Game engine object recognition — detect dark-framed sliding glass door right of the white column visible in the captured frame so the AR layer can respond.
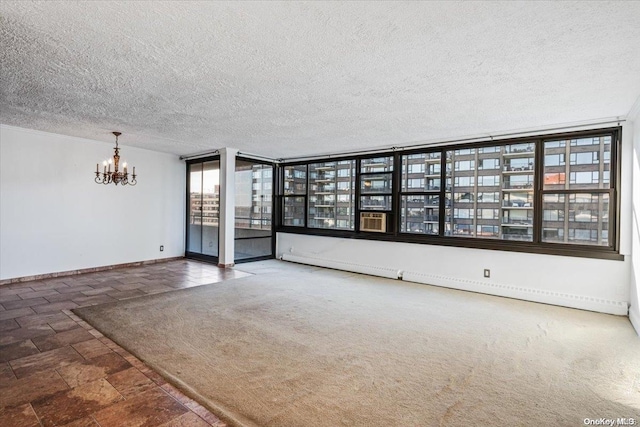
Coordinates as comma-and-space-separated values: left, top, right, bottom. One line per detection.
234, 159, 273, 262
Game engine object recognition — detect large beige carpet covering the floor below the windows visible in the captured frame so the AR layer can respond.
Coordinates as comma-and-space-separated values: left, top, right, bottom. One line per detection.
75, 261, 640, 426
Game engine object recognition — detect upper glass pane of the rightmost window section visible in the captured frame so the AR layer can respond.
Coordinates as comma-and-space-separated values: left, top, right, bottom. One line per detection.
544, 135, 611, 190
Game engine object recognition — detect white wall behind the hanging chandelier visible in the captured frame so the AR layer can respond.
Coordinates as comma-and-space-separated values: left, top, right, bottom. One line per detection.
0, 125, 185, 279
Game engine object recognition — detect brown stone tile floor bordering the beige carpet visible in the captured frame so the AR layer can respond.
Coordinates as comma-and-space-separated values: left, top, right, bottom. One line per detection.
0, 260, 249, 427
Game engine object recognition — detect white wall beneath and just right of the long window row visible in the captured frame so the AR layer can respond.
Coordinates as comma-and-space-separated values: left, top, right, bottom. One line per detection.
277, 124, 640, 318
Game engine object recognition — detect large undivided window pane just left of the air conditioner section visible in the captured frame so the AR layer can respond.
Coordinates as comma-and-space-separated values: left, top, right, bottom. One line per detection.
308, 160, 356, 230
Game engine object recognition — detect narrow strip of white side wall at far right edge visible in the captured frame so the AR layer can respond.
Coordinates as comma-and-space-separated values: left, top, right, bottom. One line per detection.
629, 103, 640, 335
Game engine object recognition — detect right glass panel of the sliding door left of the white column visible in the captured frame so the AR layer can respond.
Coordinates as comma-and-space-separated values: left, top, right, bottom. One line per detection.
201, 160, 220, 256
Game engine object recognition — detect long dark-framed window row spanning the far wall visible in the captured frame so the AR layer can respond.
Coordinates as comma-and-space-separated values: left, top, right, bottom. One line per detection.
281, 129, 620, 259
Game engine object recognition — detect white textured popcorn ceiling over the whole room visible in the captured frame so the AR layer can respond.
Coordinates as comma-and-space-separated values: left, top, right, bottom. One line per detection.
0, 1, 640, 157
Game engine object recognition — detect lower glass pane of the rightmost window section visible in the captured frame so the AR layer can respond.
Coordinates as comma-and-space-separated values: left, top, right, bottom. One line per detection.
542, 193, 610, 246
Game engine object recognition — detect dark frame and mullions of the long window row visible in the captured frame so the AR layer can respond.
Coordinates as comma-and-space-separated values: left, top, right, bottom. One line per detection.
276, 127, 624, 260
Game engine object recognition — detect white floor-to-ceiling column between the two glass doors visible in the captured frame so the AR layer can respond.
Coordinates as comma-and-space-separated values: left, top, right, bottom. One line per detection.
218, 148, 238, 268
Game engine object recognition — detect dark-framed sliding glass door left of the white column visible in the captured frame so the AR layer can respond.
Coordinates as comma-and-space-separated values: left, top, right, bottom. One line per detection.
186, 159, 220, 262
